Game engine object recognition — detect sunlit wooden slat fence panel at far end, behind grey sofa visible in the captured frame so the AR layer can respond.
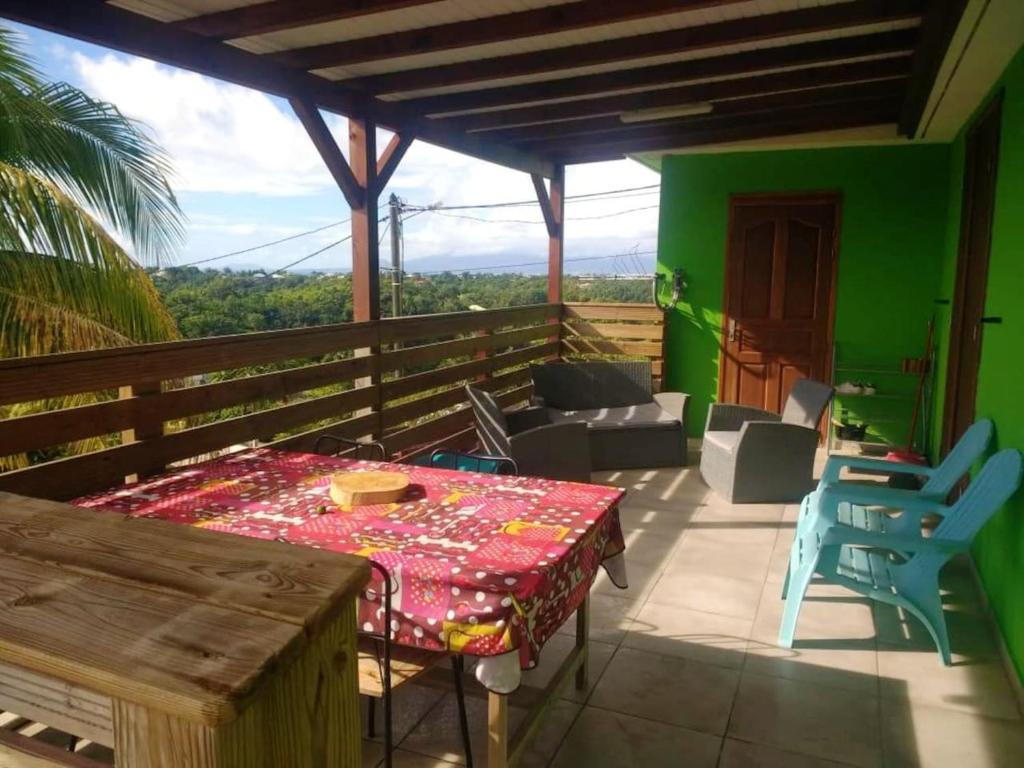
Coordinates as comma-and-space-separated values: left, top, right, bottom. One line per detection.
560, 303, 665, 390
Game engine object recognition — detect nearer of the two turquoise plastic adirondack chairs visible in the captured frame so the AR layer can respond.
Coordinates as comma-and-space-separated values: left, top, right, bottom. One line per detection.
778, 449, 1021, 666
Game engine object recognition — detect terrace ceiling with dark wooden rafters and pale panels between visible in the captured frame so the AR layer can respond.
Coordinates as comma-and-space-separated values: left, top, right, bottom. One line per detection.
0, 0, 966, 176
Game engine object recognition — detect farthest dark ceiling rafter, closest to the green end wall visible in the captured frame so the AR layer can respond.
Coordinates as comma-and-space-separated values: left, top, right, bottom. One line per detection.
556, 98, 900, 163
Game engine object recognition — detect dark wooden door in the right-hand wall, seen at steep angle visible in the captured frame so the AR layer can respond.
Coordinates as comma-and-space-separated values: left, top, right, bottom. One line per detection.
942, 98, 1001, 453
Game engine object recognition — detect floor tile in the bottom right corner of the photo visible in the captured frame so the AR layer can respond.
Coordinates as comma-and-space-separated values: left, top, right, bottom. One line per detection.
882, 699, 1024, 768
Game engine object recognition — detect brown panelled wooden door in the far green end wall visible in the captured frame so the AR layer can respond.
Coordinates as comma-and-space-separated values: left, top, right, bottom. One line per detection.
719, 196, 839, 412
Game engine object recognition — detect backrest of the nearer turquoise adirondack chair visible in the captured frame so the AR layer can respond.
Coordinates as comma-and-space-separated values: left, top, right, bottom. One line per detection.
905, 449, 1022, 570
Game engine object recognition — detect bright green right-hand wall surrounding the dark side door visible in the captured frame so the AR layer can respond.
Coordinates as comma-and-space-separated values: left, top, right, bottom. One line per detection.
937, 48, 1024, 679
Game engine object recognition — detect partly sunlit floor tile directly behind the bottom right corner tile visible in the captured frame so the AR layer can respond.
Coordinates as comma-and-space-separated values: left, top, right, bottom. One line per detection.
879, 643, 1021, 720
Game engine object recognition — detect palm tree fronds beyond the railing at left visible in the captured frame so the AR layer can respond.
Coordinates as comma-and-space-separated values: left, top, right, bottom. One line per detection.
0, 28, 183, 357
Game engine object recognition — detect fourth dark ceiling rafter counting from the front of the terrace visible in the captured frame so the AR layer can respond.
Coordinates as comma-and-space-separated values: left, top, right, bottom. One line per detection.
402, 29, 918, 114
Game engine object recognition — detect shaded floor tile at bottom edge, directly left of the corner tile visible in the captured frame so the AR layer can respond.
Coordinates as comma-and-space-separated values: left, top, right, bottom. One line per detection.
728, 673, 882, 768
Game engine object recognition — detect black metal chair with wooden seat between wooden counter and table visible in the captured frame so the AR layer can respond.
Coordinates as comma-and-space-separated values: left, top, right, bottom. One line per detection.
358, 560, 473, 768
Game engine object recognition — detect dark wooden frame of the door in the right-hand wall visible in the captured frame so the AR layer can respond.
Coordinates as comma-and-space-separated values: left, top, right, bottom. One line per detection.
939, 96, 1004, 456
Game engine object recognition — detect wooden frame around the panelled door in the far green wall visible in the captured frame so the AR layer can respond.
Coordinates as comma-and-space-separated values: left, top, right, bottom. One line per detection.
717, 189, 843, 403
